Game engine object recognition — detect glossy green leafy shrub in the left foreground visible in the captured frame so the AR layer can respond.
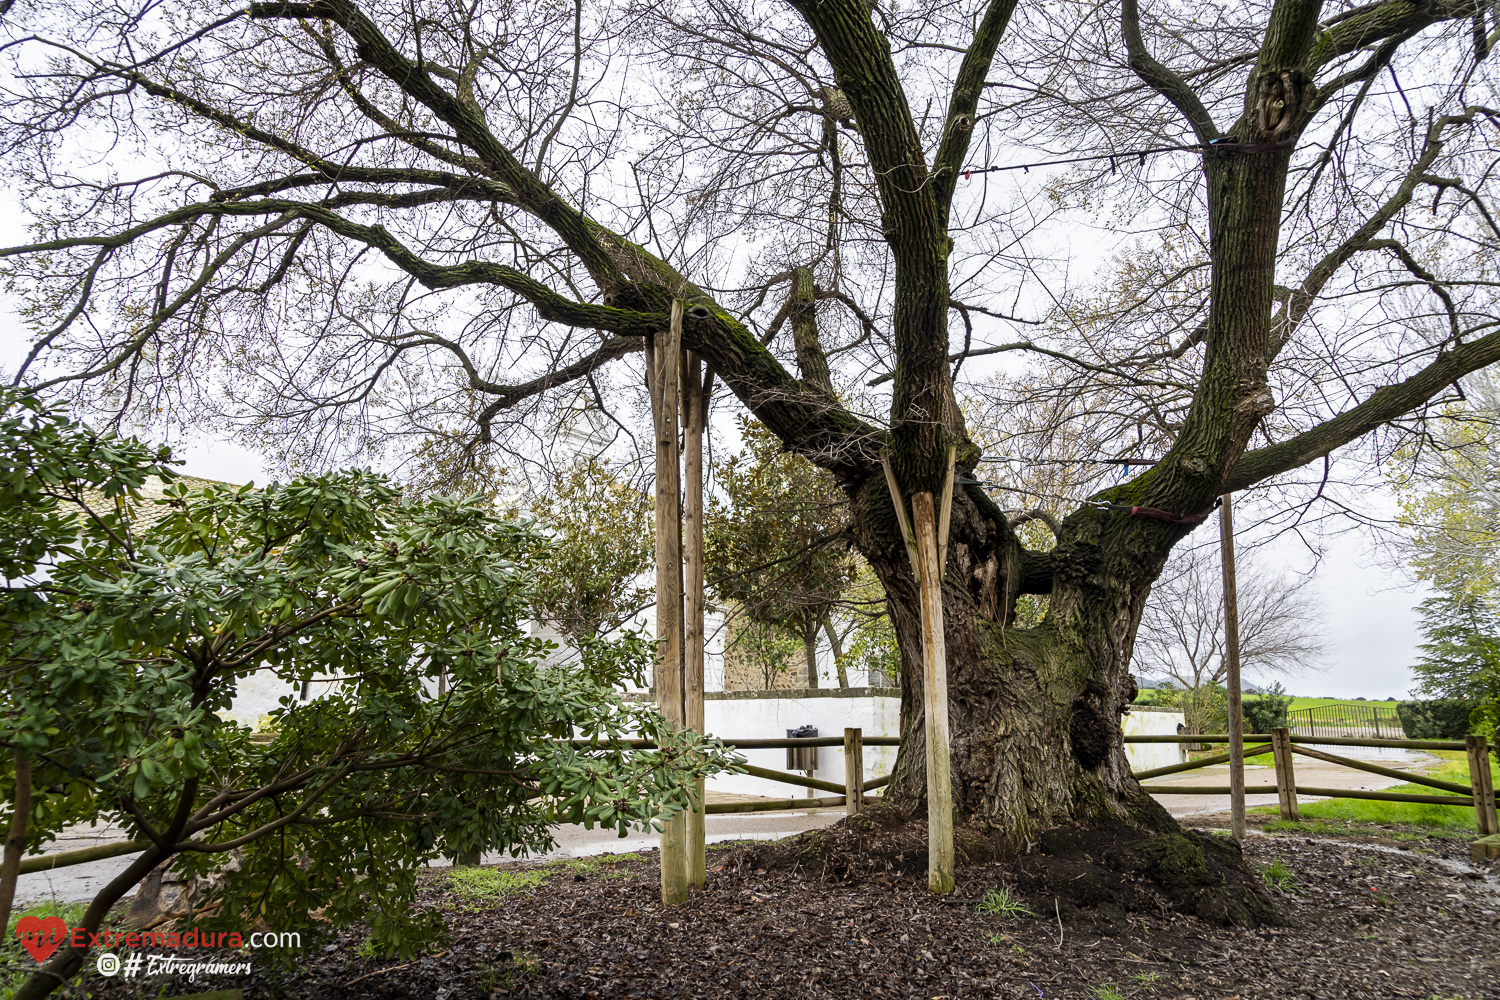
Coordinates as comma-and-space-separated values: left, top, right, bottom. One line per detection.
0, 393, 732, 996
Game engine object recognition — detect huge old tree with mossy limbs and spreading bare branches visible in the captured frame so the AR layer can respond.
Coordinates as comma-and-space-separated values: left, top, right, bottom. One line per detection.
3, 0, 1500, 893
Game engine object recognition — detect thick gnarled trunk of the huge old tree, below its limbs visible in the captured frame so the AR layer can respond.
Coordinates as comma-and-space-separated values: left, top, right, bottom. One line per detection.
855, 470, 1184, 849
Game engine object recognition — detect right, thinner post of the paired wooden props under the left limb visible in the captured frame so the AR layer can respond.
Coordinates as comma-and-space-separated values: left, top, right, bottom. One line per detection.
683, 351, 708, 889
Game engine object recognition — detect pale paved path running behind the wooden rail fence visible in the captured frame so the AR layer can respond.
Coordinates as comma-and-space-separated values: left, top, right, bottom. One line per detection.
8, 753, 1442, 903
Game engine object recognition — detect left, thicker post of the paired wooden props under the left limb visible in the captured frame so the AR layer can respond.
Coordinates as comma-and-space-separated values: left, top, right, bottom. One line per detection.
648, 300, 689, 906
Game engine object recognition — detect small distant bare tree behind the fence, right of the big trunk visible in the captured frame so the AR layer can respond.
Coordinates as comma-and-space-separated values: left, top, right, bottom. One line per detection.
1134, 546, 1329, 688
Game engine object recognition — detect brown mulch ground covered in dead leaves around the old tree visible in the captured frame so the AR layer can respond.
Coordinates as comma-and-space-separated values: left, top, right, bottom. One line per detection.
86, 835, 1500, 1000
